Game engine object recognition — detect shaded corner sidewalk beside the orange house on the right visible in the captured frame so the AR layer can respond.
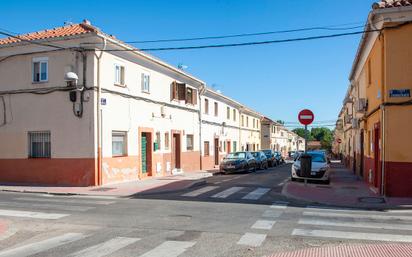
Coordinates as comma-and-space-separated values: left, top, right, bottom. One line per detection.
282, 163, 412, 209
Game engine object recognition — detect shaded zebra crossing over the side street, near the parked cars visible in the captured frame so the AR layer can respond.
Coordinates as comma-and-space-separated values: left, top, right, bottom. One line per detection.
181, 186, 271, 201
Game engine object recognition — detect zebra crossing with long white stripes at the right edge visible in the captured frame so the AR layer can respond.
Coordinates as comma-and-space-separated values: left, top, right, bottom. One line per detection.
291, 206, 412, 243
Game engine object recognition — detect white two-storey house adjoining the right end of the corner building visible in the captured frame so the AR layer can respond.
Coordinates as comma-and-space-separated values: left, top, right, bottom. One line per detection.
201, 88, 243, 170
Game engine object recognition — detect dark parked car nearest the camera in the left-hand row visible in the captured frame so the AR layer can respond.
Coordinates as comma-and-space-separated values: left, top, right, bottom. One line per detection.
219, 152, 257, 174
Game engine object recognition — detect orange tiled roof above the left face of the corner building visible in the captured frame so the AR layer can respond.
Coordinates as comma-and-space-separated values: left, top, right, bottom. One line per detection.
0, 20, 99, 45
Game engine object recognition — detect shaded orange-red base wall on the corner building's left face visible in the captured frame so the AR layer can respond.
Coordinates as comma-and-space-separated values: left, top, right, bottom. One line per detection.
0, 158, 96, 186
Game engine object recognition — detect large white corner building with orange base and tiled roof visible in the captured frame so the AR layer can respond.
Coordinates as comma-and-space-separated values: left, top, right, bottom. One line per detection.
0, 21, 204, 186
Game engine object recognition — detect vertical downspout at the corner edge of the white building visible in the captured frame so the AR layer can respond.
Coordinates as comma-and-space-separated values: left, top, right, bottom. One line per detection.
94, 37, 106, 185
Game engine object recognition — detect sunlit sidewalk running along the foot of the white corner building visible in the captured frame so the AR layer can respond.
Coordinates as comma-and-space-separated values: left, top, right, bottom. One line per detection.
0, 171, 213, 197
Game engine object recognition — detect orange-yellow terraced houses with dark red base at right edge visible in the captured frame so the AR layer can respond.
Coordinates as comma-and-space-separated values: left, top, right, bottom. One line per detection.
340, 0, 412, 197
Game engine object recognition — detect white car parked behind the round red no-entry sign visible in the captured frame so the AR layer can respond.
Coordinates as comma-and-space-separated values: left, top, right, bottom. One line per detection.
291, 151, 330, 184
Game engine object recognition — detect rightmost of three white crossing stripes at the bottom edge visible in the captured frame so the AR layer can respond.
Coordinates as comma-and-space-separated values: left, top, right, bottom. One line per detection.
140, 241, 196, 257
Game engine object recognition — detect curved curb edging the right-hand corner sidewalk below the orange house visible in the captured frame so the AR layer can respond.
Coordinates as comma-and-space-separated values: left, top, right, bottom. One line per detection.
281, 183, 412, 211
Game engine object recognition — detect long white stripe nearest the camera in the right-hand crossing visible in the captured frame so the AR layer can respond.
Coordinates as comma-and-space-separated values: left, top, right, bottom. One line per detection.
292, 229, 412, 243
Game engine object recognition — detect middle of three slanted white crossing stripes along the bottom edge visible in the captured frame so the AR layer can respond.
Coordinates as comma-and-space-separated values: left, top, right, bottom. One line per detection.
69, 237, 140, 257
